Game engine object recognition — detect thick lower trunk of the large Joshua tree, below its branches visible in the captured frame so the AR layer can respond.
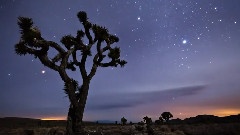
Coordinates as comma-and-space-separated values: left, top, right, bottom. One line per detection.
66, 81, 89, 135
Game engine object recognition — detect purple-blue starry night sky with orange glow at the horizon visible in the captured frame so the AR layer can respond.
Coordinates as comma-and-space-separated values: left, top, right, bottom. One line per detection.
0, 0, 240, 121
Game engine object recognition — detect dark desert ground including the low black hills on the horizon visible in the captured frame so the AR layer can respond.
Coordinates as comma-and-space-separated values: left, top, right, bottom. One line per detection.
0, 115, 240, 135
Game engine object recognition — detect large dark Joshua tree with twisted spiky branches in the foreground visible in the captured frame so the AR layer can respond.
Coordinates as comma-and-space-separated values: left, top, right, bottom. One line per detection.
15, 11, 127, 135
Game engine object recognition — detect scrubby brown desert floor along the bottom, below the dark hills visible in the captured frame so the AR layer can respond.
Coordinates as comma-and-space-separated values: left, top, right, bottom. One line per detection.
0, 123, 240, 135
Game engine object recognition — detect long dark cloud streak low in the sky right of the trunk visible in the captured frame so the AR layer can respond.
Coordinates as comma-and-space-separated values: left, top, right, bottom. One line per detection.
88, 85, 207, 110
